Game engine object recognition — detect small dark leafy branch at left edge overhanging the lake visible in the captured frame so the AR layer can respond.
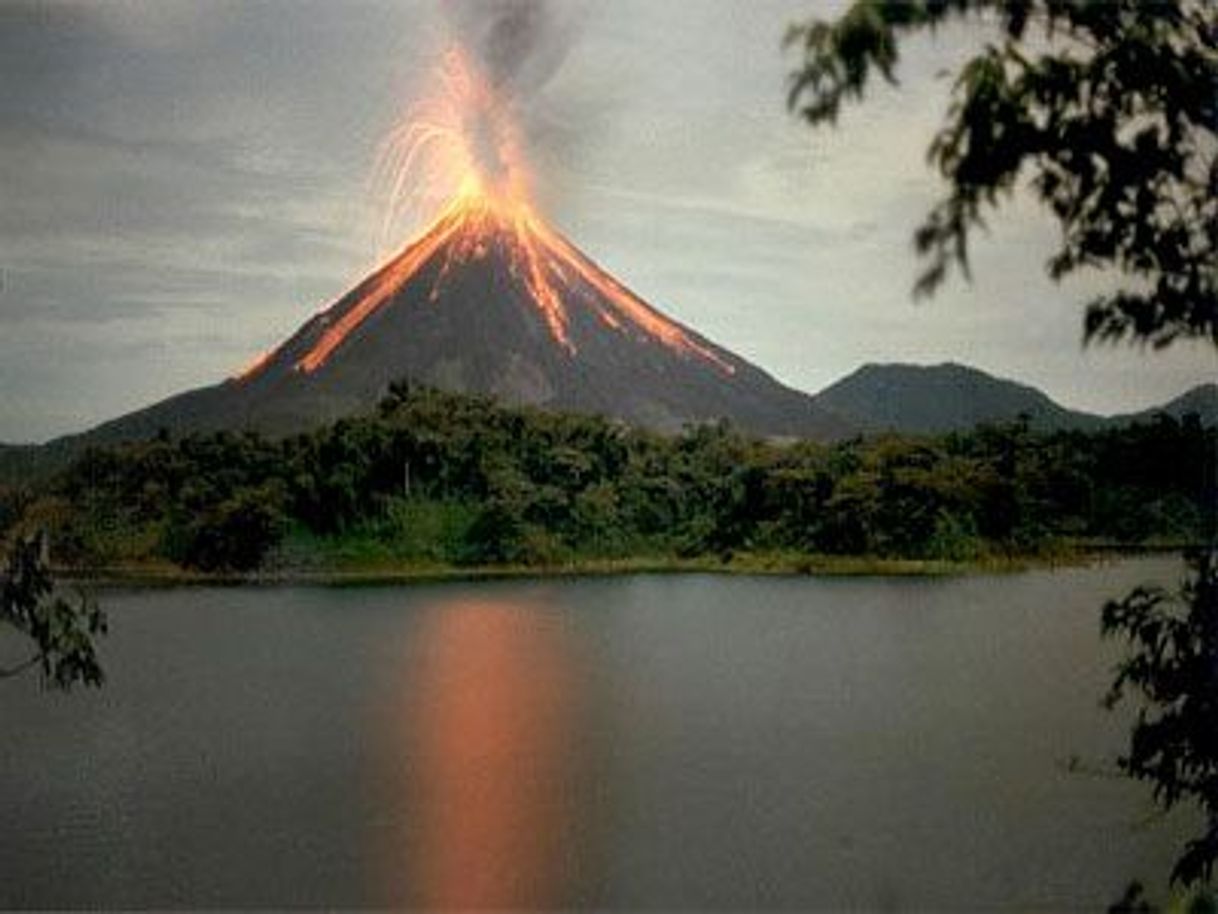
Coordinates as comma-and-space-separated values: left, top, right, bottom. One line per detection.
0, 535, 106, 689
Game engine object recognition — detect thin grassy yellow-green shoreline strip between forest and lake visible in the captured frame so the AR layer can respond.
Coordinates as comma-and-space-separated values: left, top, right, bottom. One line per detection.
47, 547, 1179, 587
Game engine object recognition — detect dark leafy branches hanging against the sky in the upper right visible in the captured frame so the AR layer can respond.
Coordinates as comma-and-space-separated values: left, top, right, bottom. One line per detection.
788, 0, 1218, 346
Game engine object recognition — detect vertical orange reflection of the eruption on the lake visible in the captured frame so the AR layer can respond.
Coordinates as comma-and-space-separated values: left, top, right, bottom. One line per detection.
413, 603, 577, 909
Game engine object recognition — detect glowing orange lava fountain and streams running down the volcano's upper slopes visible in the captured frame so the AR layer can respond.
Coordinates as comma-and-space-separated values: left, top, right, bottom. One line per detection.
245, 51, 734, 378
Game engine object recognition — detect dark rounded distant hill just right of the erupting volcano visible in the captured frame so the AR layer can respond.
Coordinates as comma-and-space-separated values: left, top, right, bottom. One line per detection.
814, 362, 1106, 434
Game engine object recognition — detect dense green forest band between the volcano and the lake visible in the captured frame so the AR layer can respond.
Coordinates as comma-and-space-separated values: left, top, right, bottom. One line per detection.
0, 385, 1218, 572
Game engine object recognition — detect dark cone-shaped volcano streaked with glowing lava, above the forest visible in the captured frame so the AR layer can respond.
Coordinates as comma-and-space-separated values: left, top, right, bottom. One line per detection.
78, 194, 848, 440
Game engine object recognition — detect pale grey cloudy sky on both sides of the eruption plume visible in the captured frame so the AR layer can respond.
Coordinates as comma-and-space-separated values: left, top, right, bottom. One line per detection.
0, 0, 1218, 441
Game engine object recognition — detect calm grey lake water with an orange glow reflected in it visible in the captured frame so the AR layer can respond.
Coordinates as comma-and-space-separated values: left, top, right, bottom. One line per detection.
0, 561, 1188, 910
